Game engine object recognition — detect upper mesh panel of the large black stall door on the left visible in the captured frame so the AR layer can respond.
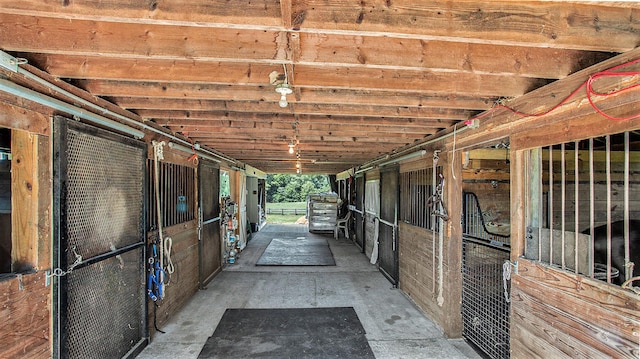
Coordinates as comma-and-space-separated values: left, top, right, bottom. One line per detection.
66, 131, 144, 263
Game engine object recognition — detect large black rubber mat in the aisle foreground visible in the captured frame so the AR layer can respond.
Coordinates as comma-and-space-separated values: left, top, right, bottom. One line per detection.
198, 307, 375, 359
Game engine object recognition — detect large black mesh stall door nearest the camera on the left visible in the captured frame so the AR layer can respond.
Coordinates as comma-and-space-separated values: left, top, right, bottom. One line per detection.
54, 118, 147, 358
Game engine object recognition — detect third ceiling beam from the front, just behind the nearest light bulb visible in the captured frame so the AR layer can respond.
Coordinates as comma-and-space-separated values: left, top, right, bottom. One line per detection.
23, 54, 548, 97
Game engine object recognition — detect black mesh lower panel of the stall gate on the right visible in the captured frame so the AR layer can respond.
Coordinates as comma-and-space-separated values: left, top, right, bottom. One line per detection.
462, 240, 510, 358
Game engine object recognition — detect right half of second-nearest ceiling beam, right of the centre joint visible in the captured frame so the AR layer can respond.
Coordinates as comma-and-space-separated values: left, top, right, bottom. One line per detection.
300, 33, 612, 79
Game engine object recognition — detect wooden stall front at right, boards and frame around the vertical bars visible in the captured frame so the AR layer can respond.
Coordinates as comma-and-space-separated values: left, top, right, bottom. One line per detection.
511, 89, 640, 358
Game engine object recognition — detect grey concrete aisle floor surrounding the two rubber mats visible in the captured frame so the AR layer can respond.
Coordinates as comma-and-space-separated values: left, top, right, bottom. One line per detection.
138, 224, 480, 359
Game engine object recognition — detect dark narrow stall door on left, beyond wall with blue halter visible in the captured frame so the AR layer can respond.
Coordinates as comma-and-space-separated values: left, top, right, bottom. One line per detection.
198, 159, 222, 288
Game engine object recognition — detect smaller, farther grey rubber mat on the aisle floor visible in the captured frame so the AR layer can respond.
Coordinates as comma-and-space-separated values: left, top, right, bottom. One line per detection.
256, 237, 336, 266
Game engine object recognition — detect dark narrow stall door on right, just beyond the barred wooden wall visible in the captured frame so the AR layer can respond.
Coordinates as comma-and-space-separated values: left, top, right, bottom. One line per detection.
378, 167, 399, 285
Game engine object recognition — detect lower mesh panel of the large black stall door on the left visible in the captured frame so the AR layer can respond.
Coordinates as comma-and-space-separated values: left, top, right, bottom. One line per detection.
66, 247, 145, 358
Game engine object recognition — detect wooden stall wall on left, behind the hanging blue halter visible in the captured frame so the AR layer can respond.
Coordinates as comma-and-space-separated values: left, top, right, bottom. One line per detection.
147, 147, 199, 334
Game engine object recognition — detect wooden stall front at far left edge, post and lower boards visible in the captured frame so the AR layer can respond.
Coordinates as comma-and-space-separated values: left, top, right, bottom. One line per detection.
0, 119, 52, 358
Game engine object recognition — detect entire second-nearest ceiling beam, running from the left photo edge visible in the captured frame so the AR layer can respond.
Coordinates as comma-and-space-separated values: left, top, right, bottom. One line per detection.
0, 13, 612, 79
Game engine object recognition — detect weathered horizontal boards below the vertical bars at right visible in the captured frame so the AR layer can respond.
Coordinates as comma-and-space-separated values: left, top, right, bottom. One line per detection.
511, 259, 640, 358
